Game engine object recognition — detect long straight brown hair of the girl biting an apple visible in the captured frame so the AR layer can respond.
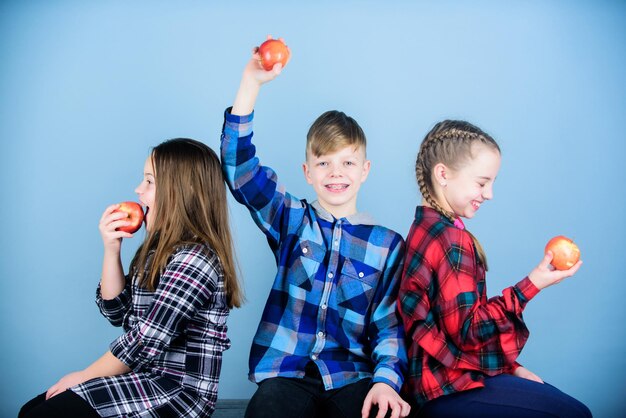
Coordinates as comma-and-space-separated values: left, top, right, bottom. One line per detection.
131, 138, 243, 308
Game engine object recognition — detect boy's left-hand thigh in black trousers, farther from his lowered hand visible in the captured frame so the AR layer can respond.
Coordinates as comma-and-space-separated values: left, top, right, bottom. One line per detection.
245, 377, 323, 418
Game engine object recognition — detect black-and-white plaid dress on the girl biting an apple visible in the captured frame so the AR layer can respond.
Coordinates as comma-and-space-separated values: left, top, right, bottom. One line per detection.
71, 244, 230, 417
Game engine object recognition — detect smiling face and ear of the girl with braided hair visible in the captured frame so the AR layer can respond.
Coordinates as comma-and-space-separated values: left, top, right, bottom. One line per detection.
433, 144, 501, 218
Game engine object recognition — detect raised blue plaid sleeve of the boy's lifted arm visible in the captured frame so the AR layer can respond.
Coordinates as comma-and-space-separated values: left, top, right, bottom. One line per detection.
220, 108, 304, 250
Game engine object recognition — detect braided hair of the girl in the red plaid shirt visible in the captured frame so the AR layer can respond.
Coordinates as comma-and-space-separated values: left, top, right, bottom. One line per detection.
415, 120, 500, 269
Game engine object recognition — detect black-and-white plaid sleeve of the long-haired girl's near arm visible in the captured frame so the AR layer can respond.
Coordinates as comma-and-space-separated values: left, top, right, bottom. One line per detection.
110, 245, 218, 370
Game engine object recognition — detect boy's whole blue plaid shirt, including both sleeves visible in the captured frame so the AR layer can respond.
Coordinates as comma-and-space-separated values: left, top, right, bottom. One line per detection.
221, 109, 407, 391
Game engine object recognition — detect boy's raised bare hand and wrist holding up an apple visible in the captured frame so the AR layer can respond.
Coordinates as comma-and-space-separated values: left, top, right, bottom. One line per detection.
231, 36, 283, 116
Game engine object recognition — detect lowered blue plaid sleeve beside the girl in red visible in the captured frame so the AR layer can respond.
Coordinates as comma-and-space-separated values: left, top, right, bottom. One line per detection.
369, 235, 407, 392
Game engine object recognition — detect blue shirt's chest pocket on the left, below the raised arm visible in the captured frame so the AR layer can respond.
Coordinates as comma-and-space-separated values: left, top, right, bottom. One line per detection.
287, 241, 326, 291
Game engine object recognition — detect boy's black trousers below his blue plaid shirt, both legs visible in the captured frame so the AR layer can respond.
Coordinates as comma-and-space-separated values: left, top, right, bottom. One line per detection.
245, 363, 389, 418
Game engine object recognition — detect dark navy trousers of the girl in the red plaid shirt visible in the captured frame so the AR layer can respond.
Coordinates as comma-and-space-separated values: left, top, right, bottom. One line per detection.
411, 374, 591, 418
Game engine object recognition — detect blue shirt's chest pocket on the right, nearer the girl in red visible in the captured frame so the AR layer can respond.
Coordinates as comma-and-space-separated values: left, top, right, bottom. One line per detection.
337, 258, 380, 315
